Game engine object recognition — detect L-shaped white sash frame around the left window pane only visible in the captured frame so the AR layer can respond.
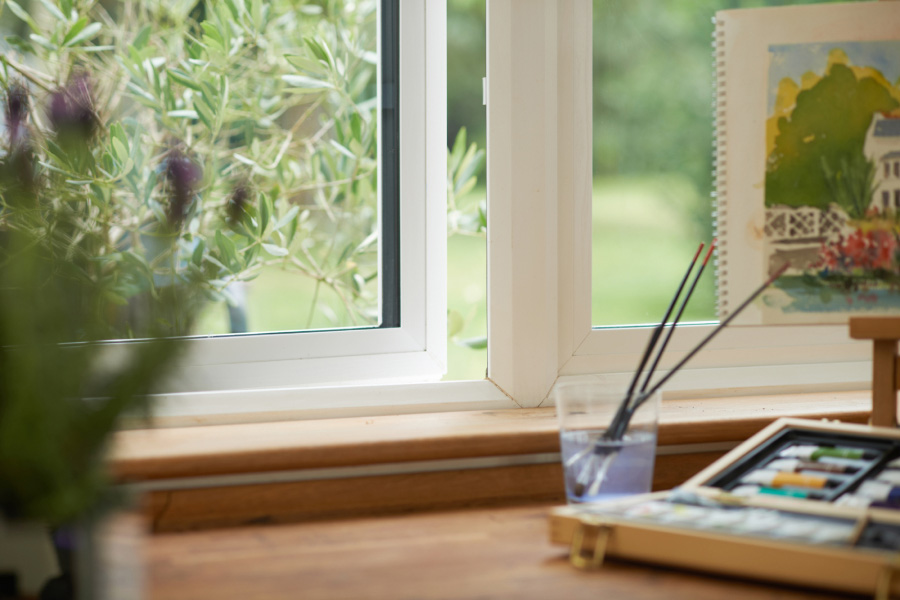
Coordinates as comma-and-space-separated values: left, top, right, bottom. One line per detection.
153, 2, 447, 392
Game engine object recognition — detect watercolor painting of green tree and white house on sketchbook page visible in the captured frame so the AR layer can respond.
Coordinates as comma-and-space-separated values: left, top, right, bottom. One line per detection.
763, 41, 900, 322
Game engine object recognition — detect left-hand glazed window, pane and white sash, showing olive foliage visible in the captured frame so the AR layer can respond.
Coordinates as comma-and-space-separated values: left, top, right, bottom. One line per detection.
0, 0, 444, 398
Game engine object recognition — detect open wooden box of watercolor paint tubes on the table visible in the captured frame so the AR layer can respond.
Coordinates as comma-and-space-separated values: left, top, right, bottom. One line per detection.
550, 419, 900, 597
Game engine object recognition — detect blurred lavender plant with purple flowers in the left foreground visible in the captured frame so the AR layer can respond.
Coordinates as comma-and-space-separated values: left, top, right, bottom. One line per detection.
0, 79, 203, 524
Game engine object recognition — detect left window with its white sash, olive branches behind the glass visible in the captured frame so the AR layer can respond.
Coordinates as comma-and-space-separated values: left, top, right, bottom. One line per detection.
2, 0, 446, 400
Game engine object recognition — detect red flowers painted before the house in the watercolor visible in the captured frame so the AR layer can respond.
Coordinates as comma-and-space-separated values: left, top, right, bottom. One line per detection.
818, 229, 900, 274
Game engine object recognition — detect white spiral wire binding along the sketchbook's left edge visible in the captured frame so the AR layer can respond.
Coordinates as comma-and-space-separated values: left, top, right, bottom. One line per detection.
712, 17, 728, 321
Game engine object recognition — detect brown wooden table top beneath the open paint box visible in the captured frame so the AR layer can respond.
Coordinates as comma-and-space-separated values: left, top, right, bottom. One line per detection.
145, 506, 864, 600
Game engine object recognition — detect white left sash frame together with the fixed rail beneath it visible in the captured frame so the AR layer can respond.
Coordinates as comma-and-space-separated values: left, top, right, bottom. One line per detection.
154, 0, 517, 426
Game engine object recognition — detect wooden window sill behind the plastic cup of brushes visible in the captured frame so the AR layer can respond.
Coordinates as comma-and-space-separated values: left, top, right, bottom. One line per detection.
111, 391, 871, 530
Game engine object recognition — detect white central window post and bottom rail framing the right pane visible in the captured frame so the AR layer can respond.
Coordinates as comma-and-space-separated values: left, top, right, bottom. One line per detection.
488, 0, 869, 406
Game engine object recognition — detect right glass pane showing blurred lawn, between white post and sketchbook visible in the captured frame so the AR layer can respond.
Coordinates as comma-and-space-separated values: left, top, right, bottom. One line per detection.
592, 0, 856, 326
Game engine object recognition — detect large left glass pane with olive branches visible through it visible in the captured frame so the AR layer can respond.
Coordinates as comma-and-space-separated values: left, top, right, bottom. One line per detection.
0, 0, 399, 337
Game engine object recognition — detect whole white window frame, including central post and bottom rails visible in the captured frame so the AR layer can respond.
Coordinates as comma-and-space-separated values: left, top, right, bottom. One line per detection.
148, 0, 871, 424
